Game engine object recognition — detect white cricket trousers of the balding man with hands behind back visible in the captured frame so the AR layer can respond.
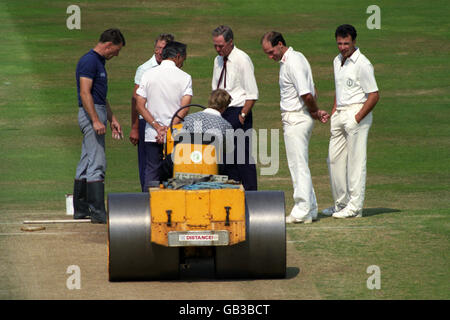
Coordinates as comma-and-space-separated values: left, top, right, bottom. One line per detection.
281, 109, 317, 219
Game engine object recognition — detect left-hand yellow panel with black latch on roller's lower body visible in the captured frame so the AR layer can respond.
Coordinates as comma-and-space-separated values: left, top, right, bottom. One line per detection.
150, 189, 186, 223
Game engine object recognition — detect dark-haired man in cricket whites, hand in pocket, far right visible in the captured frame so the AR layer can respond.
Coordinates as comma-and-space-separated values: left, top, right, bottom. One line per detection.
322, 24, 379, 218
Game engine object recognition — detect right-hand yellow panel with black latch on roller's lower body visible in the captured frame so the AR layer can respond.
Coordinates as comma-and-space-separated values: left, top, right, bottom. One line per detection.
210, 189, 245, 221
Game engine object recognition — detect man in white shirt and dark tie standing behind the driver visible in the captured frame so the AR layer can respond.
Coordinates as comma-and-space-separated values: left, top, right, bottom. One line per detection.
211, 26, 258, 190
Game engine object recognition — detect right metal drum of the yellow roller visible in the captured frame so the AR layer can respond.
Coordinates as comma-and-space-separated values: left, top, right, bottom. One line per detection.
215, 191, 286, 278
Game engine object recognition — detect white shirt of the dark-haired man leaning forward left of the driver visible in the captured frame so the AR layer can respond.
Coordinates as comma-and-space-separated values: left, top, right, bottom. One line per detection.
136, 60, 192, 142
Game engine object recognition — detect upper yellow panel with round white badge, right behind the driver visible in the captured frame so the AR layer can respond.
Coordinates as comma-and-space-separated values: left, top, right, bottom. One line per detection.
173, 143, 219, 174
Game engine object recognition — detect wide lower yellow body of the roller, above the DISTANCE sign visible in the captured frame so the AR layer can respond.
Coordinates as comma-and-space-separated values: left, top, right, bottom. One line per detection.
150, 189, 245, 246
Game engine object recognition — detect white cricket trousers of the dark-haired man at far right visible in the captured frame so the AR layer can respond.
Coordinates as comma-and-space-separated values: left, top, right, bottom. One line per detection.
327, 104, 372, 212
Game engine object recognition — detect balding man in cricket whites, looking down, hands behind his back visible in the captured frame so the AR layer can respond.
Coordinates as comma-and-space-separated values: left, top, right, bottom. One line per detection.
261, 31, 329, 223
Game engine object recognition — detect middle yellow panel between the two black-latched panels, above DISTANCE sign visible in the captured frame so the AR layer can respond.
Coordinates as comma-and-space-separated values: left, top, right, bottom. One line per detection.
186, 190, 211, 227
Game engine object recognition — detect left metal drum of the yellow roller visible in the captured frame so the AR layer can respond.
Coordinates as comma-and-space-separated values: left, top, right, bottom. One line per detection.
108, 193, 179, 281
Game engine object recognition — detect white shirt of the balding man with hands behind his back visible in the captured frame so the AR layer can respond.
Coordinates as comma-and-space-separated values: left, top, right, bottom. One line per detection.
279, 47, 315, 112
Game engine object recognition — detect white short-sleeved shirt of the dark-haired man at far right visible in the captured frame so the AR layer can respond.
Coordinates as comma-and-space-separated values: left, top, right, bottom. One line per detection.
333, 48, 378, 109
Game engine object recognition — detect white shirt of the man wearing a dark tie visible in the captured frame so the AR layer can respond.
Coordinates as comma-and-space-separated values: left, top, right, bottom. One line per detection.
211, 47, 258, 107
